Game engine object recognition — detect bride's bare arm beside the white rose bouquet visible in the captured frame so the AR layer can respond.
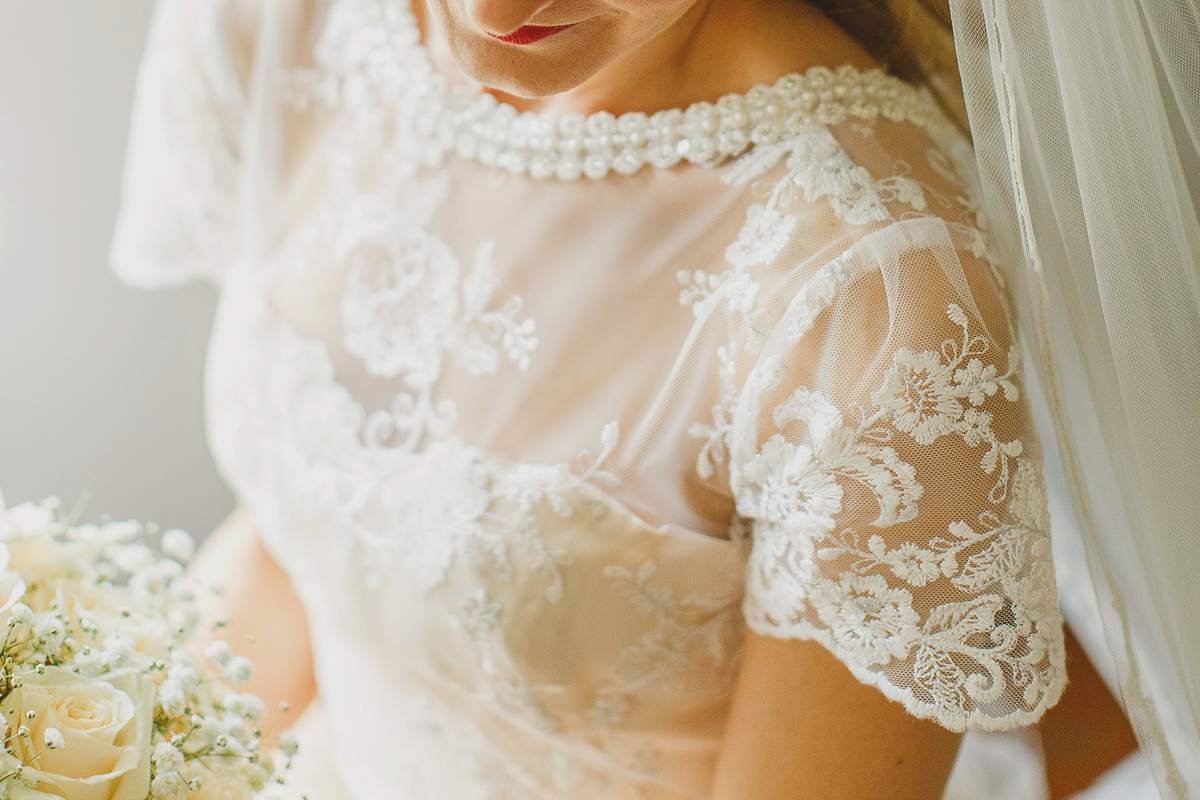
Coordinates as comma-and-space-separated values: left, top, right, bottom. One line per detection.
192, 507, 317, 733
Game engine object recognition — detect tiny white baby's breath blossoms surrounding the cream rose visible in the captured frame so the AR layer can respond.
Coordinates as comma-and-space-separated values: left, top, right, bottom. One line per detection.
0, 499, 295, 800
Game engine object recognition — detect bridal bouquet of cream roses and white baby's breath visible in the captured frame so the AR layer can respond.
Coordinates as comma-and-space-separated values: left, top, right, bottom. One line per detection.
0, 499, 289, 800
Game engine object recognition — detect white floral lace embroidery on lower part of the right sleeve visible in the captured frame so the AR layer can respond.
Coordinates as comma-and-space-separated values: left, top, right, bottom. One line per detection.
732, 303, 1063, 730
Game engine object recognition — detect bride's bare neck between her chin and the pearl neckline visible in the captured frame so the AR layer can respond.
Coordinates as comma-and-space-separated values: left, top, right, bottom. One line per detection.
413, 0, 877, 114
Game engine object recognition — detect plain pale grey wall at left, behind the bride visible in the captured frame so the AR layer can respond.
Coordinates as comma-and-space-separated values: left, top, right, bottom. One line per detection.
0, 0, 233, 535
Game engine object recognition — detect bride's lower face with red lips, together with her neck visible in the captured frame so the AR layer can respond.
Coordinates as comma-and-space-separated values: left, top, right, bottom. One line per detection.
415, 0, 875, 114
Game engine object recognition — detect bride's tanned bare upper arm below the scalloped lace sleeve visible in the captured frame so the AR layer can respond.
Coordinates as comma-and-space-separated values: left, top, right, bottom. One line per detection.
713, 632, 960, 800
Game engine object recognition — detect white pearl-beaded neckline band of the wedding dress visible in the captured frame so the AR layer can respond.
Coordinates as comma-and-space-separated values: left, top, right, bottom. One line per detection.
293, 0, 942, 180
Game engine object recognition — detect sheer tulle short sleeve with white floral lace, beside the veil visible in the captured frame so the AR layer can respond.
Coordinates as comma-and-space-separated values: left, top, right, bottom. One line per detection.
728, 122, 1064, 730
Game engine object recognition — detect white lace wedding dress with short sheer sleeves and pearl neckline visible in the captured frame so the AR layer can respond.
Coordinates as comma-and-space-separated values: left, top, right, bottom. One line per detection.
115, 0, 1064, 800
